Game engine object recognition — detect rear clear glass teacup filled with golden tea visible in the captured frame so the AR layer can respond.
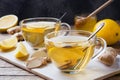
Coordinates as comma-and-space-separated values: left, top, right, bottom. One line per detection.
20, 17, 71, 49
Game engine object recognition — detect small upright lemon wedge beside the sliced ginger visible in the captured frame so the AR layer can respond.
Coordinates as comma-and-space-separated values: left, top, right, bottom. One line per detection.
15, 42, 29, 60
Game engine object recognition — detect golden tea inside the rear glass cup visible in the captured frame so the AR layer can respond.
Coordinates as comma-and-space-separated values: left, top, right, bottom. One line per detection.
21, 21, 59, 48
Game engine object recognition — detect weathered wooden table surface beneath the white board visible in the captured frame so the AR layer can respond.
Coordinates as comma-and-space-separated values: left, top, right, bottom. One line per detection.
0, 34, 120, 80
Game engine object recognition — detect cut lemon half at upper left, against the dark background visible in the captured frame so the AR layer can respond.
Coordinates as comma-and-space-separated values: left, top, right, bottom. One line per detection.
0, 15, 18, 32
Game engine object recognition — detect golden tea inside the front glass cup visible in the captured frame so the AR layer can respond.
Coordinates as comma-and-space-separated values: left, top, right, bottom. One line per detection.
45, 35, 94, 72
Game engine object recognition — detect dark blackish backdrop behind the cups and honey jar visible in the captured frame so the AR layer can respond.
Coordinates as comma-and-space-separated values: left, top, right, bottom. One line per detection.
0, 0, 120, 24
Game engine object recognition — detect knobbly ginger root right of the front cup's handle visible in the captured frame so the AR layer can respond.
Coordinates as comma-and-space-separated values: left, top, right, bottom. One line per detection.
98, 47, 117, 66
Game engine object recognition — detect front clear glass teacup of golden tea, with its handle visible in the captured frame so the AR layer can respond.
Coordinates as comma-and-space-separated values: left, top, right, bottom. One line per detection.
45, 30, 106, 73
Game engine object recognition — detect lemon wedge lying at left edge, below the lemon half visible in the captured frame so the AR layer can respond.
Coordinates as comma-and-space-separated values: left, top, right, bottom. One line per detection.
0, 37, 18, 50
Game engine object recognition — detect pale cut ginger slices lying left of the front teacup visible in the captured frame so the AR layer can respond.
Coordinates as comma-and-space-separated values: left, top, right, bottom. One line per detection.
26, 48, 51, 69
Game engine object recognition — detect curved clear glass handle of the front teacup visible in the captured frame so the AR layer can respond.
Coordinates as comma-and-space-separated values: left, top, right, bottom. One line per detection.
92, 38, 107, 59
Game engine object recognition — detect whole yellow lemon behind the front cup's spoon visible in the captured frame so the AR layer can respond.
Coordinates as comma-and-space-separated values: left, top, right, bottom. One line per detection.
93, 19, 120, 45
